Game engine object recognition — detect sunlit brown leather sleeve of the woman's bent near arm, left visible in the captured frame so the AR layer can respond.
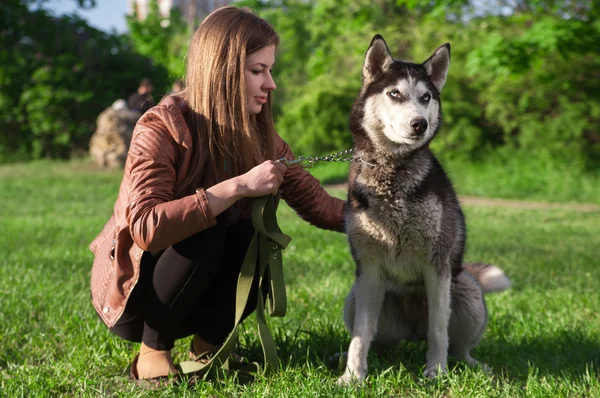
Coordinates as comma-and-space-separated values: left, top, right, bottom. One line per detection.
125, 108, 216, 252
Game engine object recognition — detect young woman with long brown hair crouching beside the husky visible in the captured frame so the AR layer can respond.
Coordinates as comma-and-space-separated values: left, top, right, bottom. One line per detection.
90, 7, 343, 380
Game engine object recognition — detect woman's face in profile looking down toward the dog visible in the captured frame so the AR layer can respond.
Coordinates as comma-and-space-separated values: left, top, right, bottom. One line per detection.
244, 46, 277, 115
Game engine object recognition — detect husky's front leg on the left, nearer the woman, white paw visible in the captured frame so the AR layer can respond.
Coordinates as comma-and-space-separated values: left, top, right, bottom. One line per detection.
338, 271, 385, 384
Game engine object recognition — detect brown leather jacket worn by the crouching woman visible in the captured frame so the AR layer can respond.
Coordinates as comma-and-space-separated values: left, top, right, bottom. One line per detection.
90, 96, 344, 327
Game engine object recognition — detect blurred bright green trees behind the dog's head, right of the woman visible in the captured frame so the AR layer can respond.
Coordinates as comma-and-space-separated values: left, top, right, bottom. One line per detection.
241, 0, 600, 170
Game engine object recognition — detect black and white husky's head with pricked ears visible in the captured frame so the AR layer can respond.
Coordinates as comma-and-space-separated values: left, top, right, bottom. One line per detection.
350, 35, 450, 155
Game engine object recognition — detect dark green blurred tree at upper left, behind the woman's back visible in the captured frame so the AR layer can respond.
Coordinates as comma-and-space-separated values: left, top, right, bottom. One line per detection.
0, 0, 167, 161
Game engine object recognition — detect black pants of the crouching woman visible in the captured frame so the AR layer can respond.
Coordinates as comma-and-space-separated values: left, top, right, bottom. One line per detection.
111, 219, 258, 350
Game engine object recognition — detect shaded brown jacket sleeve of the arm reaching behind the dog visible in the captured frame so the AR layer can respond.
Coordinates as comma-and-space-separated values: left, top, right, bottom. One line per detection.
275, 133, 345, 232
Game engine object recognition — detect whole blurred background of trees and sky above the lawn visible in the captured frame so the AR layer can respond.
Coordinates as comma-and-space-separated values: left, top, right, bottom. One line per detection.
0, 0, 600, 203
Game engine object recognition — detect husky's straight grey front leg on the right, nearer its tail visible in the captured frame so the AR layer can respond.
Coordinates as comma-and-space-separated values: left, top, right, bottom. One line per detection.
424, 267, 451, 379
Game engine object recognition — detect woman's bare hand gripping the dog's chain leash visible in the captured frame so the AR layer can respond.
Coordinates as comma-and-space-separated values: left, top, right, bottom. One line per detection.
238, 160, 287, 198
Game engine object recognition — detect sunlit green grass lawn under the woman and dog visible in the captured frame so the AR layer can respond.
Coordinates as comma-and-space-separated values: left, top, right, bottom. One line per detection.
0, 161, 600, 397
